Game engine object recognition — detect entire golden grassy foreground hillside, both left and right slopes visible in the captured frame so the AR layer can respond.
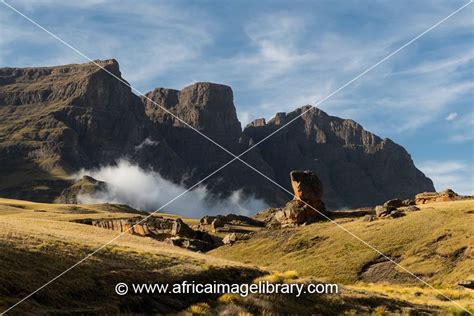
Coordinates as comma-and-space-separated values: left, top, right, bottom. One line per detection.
0, 199, 474, 315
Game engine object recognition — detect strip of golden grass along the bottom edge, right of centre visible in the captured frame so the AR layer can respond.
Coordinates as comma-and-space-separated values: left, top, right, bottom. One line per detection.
208, 271, 452, 315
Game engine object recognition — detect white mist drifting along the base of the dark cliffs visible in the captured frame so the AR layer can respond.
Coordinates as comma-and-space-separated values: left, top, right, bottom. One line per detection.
76, 160, 267, 217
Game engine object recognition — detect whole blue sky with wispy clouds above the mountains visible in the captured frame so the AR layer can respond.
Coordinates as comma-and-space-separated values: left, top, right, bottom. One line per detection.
0, 0, 474, 194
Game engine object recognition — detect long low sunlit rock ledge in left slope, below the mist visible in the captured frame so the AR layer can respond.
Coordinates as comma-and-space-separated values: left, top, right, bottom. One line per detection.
79, 216, 218, 251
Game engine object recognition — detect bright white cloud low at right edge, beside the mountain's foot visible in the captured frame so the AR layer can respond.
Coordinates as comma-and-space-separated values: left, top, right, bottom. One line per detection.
418, 160, 474, 195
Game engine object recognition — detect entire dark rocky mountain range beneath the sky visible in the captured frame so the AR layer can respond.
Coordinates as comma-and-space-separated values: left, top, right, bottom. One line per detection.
0, 60, 434, 208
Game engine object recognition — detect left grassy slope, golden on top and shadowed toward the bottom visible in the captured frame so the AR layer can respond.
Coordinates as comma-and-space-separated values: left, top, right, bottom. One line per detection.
0, 199, 260, 315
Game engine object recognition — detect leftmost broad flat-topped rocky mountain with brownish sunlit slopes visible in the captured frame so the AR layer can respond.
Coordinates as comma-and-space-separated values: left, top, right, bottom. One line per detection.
0, 60, 185, 201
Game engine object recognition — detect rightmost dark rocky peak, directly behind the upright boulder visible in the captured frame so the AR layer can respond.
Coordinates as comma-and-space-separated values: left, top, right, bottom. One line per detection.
244, 106, 433, 207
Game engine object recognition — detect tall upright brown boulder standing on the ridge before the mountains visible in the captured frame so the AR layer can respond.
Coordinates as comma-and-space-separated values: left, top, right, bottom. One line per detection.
275, 171, 326, 225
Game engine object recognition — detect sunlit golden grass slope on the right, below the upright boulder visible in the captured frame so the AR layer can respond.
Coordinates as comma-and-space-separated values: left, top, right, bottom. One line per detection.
210, 200, 474, 286
